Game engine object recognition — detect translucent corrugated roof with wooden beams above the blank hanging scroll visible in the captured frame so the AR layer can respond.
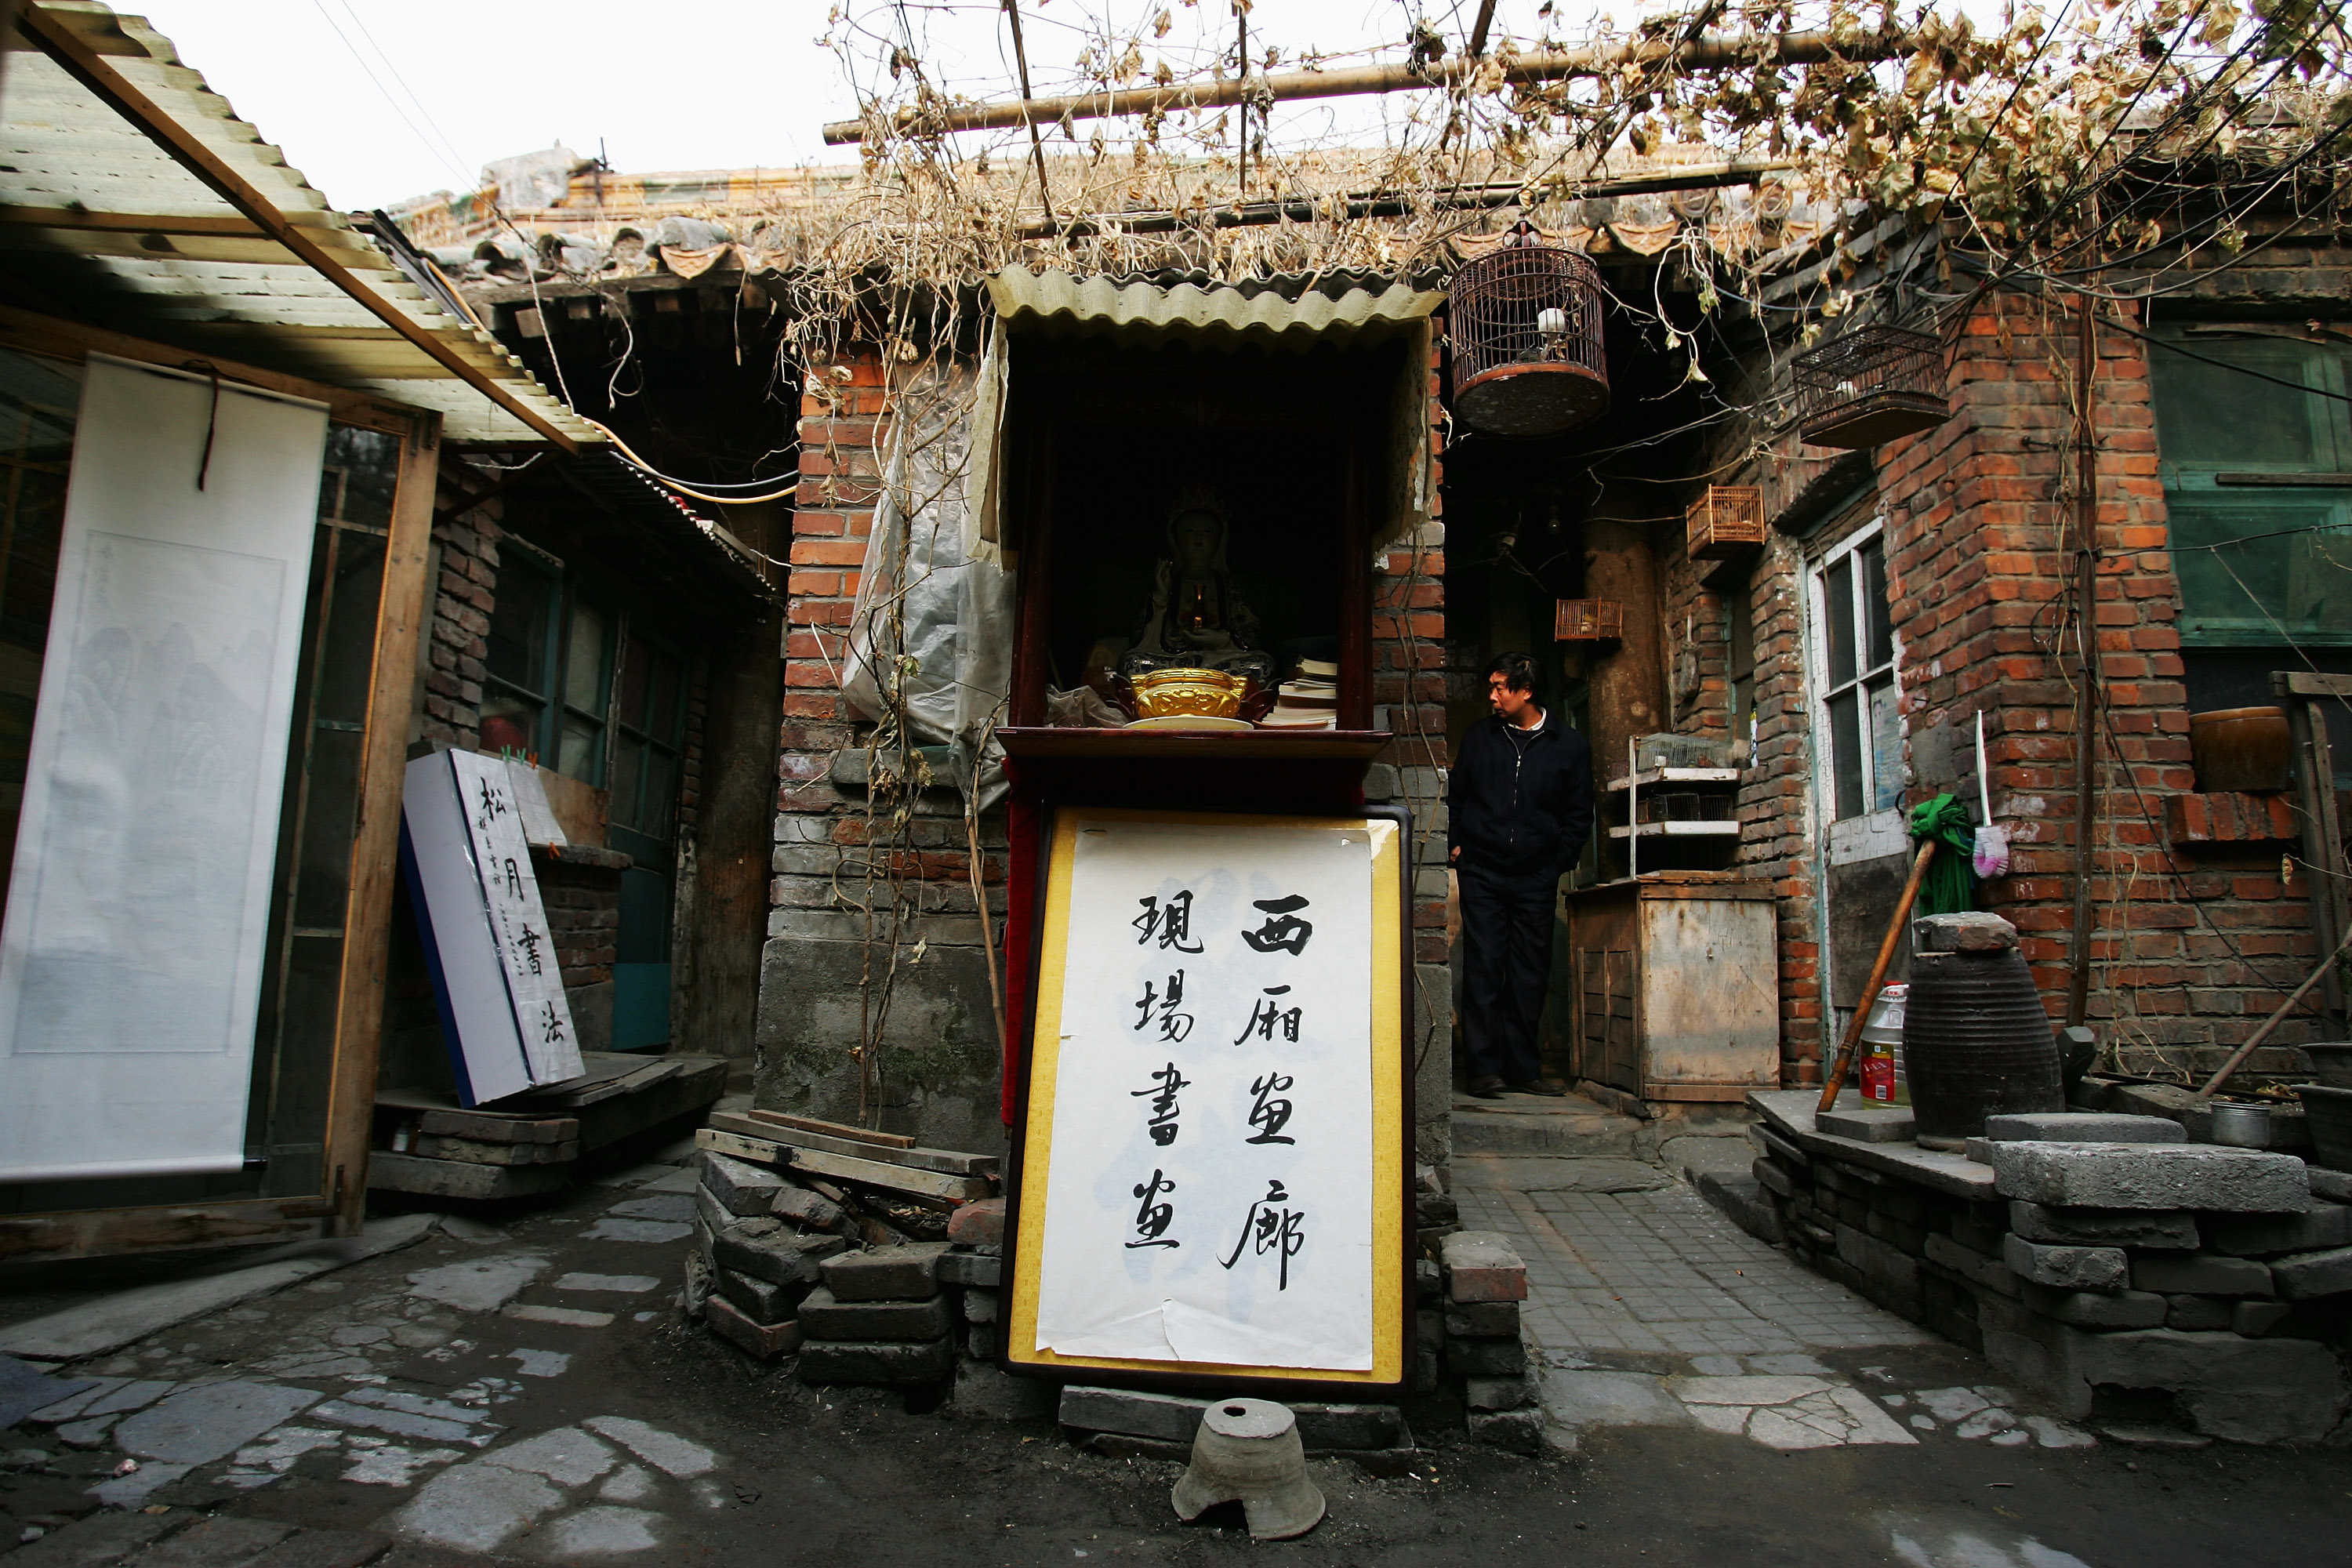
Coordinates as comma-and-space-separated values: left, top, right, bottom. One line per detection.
0, 0, 600, 442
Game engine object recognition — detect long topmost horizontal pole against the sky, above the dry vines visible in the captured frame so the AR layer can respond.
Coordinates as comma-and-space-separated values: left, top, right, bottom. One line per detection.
826, 33, 1912, 146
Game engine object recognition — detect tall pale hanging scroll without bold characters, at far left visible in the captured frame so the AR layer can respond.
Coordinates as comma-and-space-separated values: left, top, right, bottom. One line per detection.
0, 355, 327, 1182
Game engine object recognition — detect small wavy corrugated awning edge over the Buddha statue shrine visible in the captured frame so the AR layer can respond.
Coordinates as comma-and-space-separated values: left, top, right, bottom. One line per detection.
988, 268, 1446, 339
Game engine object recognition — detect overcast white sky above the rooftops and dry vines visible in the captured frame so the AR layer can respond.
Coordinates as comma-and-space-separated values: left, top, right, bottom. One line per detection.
137, 0, 1524, 207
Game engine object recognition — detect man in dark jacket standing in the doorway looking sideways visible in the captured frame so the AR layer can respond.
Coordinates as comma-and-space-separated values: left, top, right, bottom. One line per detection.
1446, 654, 1592, 1100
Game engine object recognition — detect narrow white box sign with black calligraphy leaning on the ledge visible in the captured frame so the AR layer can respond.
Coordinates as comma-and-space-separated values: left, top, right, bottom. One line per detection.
400, 753, 583, 1105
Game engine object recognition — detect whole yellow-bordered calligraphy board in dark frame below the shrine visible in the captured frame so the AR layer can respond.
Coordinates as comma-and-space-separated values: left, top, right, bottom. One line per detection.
1004, 806, 1414, 1394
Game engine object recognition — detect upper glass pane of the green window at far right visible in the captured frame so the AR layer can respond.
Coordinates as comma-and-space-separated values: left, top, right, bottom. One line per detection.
2147, 336, 2336, 473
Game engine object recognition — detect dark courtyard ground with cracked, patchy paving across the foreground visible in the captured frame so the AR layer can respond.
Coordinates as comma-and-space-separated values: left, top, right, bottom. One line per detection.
13, 1123, 2352, 1568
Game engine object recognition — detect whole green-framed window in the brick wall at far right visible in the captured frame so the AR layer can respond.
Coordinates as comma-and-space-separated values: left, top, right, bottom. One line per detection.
2147, 327, 2352, 649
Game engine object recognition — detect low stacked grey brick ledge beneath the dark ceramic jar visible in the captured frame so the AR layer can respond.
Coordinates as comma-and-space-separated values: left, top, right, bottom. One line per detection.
1736, 1112, 2352, 1443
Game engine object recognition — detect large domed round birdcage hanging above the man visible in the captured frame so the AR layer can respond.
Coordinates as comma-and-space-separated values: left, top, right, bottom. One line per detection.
1446, 226, 1609, 435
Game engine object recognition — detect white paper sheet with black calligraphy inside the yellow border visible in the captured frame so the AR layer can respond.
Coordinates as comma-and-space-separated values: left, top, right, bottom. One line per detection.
1037, 820, 1392, 1370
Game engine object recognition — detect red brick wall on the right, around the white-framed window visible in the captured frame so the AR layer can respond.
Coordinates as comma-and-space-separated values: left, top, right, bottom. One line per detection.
1668, 294, 2314, 1083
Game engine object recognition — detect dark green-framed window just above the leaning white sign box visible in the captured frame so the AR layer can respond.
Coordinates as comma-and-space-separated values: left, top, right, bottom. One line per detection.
482, 546, 619, 785
